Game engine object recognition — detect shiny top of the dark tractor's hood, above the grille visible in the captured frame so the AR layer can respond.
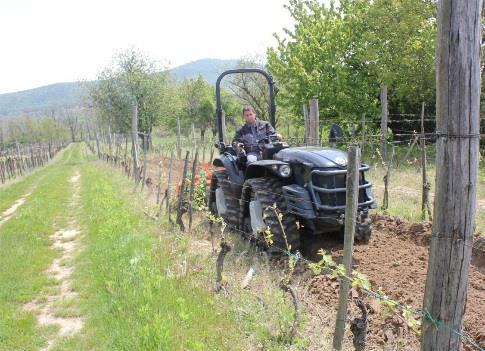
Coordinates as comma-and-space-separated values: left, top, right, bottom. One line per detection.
274, 146, 347, 169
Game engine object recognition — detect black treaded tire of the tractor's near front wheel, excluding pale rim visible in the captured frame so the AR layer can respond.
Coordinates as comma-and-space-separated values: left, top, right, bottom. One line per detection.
239, 177, 300, 253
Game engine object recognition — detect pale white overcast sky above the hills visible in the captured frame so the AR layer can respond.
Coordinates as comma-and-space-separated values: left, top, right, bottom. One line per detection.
0, 0, 292, 93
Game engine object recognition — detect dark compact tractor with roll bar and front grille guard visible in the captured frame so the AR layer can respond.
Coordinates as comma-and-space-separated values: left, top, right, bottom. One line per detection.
208, 68, 375, 251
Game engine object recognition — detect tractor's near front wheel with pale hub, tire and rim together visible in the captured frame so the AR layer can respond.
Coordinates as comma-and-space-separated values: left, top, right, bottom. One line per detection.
239, 177, 300, 253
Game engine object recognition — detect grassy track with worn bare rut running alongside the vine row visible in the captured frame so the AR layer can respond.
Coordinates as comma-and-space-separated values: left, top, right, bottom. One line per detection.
0, 145, 250, 351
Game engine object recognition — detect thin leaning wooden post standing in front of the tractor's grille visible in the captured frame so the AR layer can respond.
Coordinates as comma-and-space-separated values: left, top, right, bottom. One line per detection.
333, 145, 360, 351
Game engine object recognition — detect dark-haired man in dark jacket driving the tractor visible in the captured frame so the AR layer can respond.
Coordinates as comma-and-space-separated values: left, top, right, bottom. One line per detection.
232, 105, 280, 164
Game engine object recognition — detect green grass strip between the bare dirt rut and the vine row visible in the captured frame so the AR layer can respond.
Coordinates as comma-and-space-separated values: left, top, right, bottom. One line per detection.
57, 165, 246, 350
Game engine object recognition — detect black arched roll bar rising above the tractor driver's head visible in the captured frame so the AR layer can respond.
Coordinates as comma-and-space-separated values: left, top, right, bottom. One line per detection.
216, 68, 276, 143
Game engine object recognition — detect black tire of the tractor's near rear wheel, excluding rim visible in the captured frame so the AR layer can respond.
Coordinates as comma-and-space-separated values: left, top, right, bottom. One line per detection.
208, 170, 239, 229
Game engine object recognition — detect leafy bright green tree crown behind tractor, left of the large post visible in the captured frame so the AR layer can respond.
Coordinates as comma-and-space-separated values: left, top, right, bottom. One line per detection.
268, 0, 436, 124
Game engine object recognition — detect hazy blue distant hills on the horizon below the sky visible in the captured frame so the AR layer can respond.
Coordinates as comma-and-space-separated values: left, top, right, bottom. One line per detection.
0, 58, 237, 117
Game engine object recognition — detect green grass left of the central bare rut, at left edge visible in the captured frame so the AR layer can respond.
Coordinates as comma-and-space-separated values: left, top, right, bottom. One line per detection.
0, 147, 80, 350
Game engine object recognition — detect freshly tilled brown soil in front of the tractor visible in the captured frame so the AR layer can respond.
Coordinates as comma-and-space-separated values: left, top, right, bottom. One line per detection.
303, 216, 485, 350
